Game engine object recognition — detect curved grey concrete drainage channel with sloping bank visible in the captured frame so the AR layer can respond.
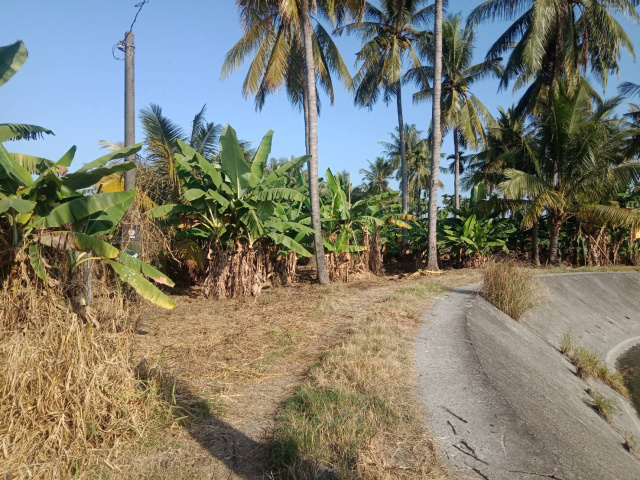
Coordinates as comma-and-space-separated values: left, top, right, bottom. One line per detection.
415, 273, 640, 480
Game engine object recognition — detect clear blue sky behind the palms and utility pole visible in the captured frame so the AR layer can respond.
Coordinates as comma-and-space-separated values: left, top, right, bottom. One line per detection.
0, 0, 640, 198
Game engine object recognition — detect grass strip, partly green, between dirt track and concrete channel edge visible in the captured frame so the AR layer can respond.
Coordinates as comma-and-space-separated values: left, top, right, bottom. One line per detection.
269, 272, 477, 479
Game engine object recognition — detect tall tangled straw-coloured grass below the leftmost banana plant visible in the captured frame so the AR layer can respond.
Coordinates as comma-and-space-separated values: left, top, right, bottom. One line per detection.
0, 266, 166, 479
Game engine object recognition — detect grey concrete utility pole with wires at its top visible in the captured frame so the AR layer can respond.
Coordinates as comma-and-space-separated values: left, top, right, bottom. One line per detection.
124, 31, 136, 190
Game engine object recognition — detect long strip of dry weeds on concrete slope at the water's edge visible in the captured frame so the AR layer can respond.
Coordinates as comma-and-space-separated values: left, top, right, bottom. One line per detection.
560, 331, 629, 398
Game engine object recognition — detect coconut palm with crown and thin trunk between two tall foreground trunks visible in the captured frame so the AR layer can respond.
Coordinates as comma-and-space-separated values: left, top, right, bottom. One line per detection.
336, 0, 434, 218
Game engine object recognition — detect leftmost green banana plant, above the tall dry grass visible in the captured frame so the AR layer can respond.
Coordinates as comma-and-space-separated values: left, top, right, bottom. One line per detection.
0, 144, 175, 308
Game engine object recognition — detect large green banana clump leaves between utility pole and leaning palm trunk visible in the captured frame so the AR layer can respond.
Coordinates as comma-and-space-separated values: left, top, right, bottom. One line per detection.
149, 127, 313, 257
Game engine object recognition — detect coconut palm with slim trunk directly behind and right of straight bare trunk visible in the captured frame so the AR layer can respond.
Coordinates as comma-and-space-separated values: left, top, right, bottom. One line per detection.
407, 14, 501, 209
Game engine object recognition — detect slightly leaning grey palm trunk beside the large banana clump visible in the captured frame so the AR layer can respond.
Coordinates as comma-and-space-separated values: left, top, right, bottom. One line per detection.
300, 0, 331, 285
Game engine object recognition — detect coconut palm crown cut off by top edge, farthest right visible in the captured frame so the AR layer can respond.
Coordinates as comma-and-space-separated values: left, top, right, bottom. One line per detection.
469, 0, 639, 111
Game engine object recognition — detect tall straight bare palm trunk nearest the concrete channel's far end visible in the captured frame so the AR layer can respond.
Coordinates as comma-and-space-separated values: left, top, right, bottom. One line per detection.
427, 0, 442, 271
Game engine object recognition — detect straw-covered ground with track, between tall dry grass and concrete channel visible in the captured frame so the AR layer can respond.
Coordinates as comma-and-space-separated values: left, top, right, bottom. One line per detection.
102, 271, 479, 479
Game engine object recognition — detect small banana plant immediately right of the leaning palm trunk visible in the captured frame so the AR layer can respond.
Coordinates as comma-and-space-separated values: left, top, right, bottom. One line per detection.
320, 169, 414, 254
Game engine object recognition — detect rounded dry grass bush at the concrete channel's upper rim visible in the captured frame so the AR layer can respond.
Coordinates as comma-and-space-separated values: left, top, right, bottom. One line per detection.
482, 261, 538, 320
